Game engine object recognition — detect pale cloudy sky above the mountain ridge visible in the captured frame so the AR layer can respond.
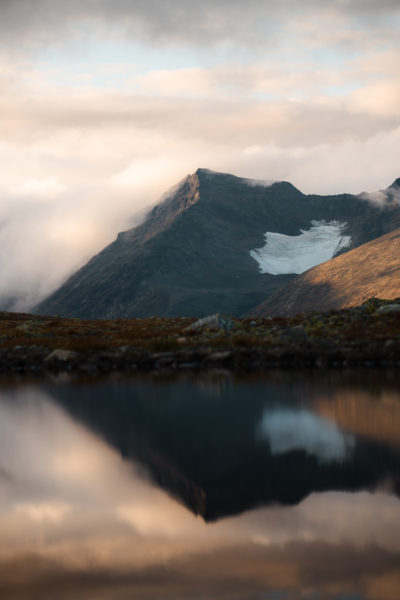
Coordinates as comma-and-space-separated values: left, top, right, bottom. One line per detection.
0, 0, 400, 310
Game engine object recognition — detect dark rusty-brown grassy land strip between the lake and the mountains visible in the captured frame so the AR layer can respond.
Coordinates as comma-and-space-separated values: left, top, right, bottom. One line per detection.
0, 299, 400, 373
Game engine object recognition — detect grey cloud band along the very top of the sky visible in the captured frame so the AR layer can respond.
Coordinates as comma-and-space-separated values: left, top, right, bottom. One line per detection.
0, 0, 399, 51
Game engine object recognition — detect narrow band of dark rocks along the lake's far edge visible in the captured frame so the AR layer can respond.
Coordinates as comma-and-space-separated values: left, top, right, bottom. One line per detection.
0, 344, 400, 375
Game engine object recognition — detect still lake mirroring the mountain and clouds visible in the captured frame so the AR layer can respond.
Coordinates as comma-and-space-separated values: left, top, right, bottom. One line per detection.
0, 371, 400, 600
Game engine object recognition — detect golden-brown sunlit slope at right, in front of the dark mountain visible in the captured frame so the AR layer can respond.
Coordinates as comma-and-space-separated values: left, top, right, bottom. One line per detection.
249, 229, 400, 317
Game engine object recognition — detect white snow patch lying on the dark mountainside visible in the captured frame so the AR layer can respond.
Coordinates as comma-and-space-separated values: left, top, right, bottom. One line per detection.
250, 221, 351, 275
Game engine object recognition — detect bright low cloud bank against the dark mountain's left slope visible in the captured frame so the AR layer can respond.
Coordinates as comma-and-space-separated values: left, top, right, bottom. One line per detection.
0, 187, 150, 311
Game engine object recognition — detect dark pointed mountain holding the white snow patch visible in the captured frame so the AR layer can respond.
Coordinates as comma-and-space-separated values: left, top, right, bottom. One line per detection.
34, 169, 400, 318
